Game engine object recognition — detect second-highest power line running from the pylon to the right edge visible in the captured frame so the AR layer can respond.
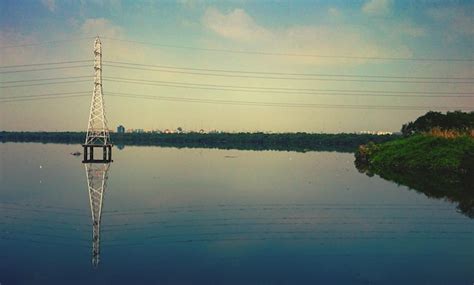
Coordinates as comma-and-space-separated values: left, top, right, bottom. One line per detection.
104, 60, 474, 80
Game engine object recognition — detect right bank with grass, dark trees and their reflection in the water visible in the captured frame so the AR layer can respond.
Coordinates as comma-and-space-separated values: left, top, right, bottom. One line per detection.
355, 112, 474, 218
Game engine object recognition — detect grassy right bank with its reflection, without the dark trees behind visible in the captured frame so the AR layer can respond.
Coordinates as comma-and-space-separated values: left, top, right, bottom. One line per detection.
354, 134, 474, 218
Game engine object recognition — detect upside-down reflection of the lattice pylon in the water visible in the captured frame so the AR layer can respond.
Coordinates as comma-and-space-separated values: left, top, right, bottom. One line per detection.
84, 163, 110, 267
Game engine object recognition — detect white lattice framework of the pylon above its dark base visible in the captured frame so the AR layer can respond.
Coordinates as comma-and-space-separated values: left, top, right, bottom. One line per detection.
85, 37, 110, 145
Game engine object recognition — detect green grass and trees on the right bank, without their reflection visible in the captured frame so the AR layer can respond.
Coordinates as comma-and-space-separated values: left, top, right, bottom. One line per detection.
355, 111, 474, 174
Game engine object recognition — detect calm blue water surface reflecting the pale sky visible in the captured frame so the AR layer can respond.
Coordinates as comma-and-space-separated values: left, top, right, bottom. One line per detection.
0, 143, 474, 285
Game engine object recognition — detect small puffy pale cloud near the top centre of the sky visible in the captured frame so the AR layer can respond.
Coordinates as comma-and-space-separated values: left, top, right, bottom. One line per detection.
202, 7, 271, 42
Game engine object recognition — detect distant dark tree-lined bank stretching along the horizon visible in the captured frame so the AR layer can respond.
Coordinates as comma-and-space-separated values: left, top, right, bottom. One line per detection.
0, 132, 399, 152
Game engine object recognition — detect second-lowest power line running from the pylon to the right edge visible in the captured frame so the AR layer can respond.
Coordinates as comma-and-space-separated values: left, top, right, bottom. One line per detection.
104, 77, 474, 98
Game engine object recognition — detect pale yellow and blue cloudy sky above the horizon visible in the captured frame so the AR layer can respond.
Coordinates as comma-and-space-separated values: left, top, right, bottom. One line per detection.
0, 0, 474, 133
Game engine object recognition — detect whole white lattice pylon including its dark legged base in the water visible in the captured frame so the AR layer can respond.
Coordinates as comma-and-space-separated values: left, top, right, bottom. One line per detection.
82, 37, 112, 162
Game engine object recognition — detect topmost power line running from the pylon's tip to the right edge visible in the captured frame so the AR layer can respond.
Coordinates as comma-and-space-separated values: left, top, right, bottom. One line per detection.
102, 37, 474, 62
